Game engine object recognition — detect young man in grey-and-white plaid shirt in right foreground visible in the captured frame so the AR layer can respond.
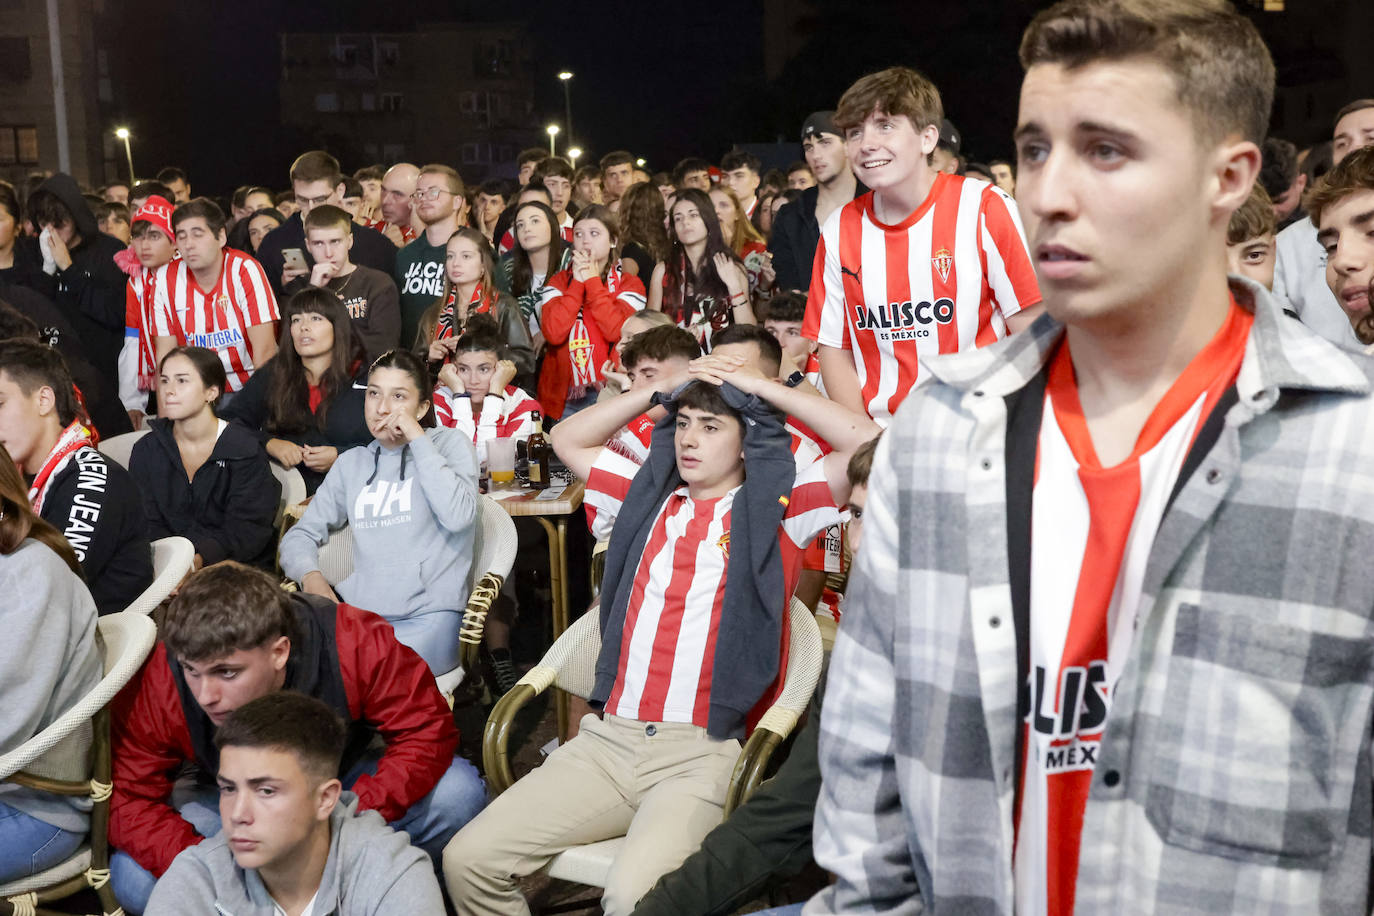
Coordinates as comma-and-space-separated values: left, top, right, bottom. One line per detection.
805, 0, 1374, 915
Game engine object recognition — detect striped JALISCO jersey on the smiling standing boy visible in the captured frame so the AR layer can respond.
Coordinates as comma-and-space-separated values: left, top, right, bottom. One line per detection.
801, 173, 1040, 426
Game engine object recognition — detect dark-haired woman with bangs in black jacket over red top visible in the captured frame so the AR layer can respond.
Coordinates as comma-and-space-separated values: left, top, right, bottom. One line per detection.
220, 287, 372, 493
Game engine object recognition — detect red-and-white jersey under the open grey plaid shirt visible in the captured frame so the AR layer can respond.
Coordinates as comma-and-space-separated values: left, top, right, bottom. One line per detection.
1014, 302, 1253, 916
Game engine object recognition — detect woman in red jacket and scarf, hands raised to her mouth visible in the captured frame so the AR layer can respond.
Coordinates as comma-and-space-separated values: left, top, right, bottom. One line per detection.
539, 203, 644, 419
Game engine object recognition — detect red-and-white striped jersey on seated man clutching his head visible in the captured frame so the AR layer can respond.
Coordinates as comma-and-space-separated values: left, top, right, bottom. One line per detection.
606, 461, 840, 728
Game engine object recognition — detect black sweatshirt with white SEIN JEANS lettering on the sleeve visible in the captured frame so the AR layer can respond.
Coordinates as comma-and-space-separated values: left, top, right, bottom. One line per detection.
41, 448, 153, 614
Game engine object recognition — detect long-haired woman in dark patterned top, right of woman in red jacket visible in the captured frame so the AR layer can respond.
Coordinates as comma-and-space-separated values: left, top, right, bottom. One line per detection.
649, 188, 757, 349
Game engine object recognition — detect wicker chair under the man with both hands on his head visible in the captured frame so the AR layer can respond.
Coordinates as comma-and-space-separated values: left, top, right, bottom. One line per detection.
482, 599, 822, 887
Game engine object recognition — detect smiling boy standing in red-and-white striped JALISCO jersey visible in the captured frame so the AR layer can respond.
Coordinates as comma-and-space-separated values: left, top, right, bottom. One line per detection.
802, 67, 1040, 426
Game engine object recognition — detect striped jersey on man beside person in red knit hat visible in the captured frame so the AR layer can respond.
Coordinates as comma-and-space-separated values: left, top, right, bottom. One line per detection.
153, 249, 282, 391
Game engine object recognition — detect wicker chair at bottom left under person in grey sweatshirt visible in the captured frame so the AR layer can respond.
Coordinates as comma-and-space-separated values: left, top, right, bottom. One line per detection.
0, 611, 158, 916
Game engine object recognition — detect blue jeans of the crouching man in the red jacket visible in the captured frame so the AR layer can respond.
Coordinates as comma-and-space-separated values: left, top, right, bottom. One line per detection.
110, 757, 486, 916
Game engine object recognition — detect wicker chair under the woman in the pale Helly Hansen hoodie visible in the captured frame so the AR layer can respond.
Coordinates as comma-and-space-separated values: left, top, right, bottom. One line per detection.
296, 496, 518, 705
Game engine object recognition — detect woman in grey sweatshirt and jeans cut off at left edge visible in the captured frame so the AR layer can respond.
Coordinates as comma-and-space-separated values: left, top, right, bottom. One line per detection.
0, 446, 102, 882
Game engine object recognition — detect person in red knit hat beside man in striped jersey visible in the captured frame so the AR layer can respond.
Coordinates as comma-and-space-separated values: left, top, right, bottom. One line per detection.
120, 194, 176, 430
